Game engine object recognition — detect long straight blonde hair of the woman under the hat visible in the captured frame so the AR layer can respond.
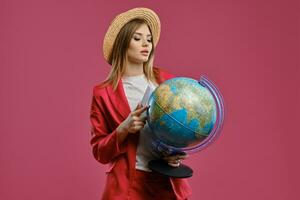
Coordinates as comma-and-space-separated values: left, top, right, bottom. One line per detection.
101, 18, 159, 90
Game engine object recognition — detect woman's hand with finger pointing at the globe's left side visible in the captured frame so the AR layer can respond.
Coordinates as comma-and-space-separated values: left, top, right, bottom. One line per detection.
117, 103, 149, 135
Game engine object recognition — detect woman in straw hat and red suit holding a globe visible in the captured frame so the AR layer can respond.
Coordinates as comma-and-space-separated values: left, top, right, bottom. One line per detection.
90, 8, 191, 199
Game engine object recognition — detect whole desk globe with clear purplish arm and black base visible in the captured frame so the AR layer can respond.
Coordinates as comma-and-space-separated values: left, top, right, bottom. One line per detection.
147, 76, 224, 178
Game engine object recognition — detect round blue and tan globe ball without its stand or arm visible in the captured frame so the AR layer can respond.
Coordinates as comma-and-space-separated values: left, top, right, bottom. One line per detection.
147, 77, 224, 151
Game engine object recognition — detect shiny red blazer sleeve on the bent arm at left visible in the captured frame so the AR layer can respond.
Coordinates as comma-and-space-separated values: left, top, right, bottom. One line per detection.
90, 90, 127, 164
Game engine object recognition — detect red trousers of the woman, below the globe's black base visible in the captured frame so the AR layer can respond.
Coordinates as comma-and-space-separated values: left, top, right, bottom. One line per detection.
130, 170, 183, 200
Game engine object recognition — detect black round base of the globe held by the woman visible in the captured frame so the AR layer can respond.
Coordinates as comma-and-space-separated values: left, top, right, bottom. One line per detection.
148, 160, 193, 178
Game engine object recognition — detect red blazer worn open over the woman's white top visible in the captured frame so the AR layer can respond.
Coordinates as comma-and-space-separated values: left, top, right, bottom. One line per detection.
90, 68, 191, 199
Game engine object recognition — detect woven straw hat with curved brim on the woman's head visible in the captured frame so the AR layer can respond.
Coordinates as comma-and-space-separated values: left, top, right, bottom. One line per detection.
103, 8, 160, 62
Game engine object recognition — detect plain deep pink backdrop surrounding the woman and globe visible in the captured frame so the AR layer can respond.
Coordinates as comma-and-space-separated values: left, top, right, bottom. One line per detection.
0, 0, 300, 200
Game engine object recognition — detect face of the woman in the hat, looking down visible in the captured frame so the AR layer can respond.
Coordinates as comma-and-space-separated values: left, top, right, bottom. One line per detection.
127, 24, 152, 63
